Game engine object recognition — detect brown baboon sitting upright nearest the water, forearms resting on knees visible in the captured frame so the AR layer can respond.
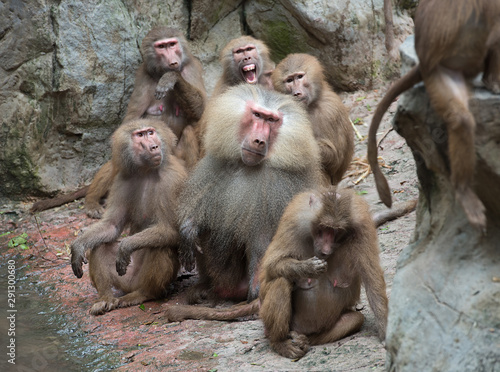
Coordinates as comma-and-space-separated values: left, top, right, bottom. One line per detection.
71, 119, 187, 315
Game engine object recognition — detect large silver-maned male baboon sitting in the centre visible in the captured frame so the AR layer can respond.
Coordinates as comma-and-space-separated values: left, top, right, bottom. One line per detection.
180, 84, 320, 303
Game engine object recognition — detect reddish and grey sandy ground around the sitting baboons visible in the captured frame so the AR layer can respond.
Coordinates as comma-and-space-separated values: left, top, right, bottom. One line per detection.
0, 83, 418, 371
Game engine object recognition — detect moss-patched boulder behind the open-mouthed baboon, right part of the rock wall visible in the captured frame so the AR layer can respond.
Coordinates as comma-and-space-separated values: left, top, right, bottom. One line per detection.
245, 0, 413, 91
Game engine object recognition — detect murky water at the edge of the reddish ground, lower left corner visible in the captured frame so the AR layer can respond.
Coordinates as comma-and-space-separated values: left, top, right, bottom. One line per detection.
0, 257, 122, 372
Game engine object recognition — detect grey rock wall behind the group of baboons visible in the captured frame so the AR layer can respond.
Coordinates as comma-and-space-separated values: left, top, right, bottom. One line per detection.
0, 0, 415, 199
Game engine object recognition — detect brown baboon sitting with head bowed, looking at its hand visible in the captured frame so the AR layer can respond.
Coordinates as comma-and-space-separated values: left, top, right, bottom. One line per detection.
259, 187, 388, 358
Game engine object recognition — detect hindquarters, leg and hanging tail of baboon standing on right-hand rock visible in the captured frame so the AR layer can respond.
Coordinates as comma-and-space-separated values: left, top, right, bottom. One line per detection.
368, 0, 500, 230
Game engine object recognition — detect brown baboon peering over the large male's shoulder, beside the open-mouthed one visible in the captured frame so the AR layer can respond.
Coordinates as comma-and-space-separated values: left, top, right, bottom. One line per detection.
272, 54, 354, 185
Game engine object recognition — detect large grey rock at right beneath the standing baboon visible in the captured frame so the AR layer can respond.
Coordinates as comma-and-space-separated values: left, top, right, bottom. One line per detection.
386, 38, 500, 372
